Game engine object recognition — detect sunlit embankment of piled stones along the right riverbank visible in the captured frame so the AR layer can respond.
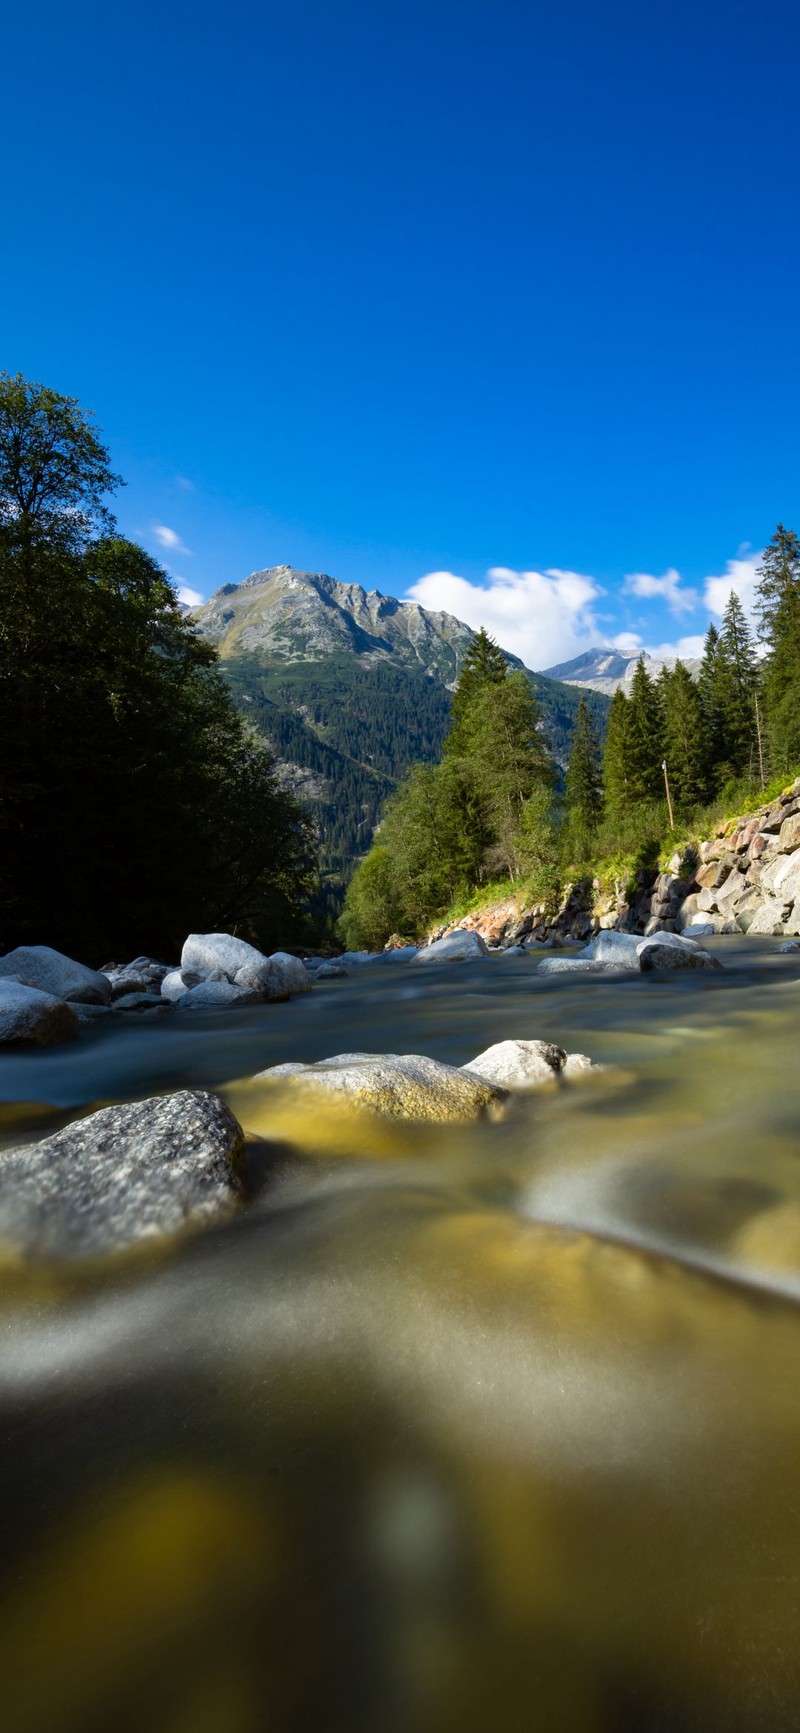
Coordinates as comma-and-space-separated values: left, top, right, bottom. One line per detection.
431, 778, 800, 946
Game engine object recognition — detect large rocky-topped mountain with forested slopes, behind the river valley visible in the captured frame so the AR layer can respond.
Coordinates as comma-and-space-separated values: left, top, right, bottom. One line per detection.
192, 565, 608, 882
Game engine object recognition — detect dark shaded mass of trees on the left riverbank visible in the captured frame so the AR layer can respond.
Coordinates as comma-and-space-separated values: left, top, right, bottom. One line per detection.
0, 374, 315, 964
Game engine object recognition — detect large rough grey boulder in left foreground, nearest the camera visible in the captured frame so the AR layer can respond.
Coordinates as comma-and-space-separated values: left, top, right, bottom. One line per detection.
0, 1090, 244, 1258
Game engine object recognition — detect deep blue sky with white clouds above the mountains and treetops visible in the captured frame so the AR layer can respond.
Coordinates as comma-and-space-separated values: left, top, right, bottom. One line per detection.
0, 0, 800, 667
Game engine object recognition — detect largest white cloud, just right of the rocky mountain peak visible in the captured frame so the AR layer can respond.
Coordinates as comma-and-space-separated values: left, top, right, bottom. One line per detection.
407, 565, 606, 669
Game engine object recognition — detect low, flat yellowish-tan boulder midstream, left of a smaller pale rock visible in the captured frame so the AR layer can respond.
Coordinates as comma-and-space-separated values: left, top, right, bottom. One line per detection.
258, 1054, 506, 1121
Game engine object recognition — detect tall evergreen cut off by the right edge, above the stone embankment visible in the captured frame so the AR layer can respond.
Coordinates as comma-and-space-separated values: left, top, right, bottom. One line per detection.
757, 523, 800, 771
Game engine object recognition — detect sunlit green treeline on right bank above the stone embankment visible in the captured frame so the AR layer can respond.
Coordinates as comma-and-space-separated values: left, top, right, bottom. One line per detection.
339, 525, 800, 944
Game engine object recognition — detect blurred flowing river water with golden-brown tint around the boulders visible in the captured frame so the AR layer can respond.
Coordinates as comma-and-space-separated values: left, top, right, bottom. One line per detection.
0, 939, 800, 1733
